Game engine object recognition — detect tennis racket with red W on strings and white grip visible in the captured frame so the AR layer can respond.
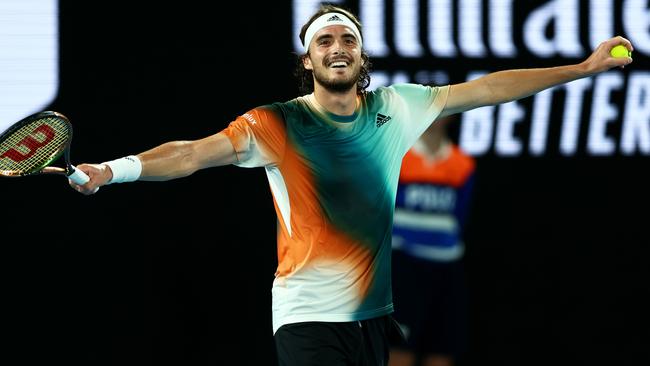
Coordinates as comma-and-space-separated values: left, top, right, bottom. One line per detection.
0, 111, 90, 184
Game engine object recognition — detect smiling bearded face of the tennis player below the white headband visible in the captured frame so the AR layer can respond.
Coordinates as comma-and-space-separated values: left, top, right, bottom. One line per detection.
303, 25, 361, 93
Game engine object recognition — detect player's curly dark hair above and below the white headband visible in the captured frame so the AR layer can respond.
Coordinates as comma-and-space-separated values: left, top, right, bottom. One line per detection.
294, 4, 372, 95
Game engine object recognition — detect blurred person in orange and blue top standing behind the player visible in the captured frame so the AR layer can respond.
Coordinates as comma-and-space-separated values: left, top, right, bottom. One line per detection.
389, 115, 475, 366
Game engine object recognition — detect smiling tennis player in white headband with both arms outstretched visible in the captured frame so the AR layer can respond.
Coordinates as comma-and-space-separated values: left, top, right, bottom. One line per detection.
71, 5, 632, 366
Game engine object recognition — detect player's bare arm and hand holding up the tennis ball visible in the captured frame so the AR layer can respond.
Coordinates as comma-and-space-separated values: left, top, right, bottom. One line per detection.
441, 37, 633, 116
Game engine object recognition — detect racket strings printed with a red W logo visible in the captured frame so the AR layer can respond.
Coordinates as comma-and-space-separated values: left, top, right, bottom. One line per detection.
0, 117, 71, 175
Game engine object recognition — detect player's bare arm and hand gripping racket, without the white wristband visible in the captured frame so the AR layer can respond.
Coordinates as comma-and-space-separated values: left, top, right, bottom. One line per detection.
70, 132, 237, 194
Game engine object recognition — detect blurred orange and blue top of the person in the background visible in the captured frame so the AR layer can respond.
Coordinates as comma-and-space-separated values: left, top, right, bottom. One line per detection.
393, 142, 475, 262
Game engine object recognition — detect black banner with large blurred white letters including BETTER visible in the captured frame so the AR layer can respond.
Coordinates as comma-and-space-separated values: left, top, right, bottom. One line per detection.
293, 0, 650, 157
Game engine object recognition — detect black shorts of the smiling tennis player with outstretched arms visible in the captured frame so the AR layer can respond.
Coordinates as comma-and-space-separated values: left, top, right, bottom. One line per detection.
274, 315, 398, 366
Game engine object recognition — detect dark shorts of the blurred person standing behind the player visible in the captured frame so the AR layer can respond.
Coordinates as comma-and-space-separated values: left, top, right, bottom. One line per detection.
393, 251, 468, 358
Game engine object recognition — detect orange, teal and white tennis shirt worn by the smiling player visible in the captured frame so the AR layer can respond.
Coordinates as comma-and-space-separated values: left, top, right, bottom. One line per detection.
223, 84, 449, 333
